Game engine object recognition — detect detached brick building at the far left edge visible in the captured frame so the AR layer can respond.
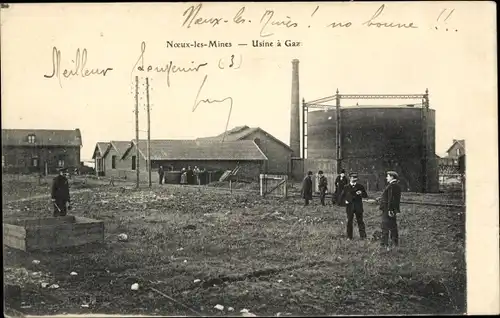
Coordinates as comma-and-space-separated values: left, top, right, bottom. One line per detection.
2, 129, 82, 174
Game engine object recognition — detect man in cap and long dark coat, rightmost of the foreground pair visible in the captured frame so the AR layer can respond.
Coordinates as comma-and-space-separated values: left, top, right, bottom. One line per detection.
379, 171, 401, 248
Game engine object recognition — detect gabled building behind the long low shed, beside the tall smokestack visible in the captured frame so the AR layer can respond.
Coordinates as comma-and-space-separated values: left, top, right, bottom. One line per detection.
197, 125, 292, 175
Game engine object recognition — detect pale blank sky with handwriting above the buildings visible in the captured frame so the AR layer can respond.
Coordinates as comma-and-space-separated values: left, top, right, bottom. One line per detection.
2, 3, 494, 160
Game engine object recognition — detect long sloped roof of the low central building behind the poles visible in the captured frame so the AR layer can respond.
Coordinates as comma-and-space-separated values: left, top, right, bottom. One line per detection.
122, 140, 267, 161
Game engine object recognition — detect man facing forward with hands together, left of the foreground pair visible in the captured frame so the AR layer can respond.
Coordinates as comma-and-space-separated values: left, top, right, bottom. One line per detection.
340, 173, 368, 240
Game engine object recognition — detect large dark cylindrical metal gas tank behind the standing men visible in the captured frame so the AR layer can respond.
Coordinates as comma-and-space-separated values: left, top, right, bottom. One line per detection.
307, 106, 439, 192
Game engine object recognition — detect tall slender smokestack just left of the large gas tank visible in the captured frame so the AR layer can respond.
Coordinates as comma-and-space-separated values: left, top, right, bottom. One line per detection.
290, 59, 300, 157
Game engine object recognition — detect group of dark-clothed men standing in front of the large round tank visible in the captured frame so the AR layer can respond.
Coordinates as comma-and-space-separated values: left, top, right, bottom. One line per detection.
302, 170, 401, 248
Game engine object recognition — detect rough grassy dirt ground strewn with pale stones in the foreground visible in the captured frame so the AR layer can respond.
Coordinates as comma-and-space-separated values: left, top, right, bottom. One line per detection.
3, 178, 466, 316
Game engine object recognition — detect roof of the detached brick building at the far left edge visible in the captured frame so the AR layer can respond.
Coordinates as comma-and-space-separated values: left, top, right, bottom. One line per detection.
2, 129, 82, 147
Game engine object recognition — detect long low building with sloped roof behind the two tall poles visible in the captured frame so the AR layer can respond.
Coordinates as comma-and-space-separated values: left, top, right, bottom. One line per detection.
112, 140, 267, 182
